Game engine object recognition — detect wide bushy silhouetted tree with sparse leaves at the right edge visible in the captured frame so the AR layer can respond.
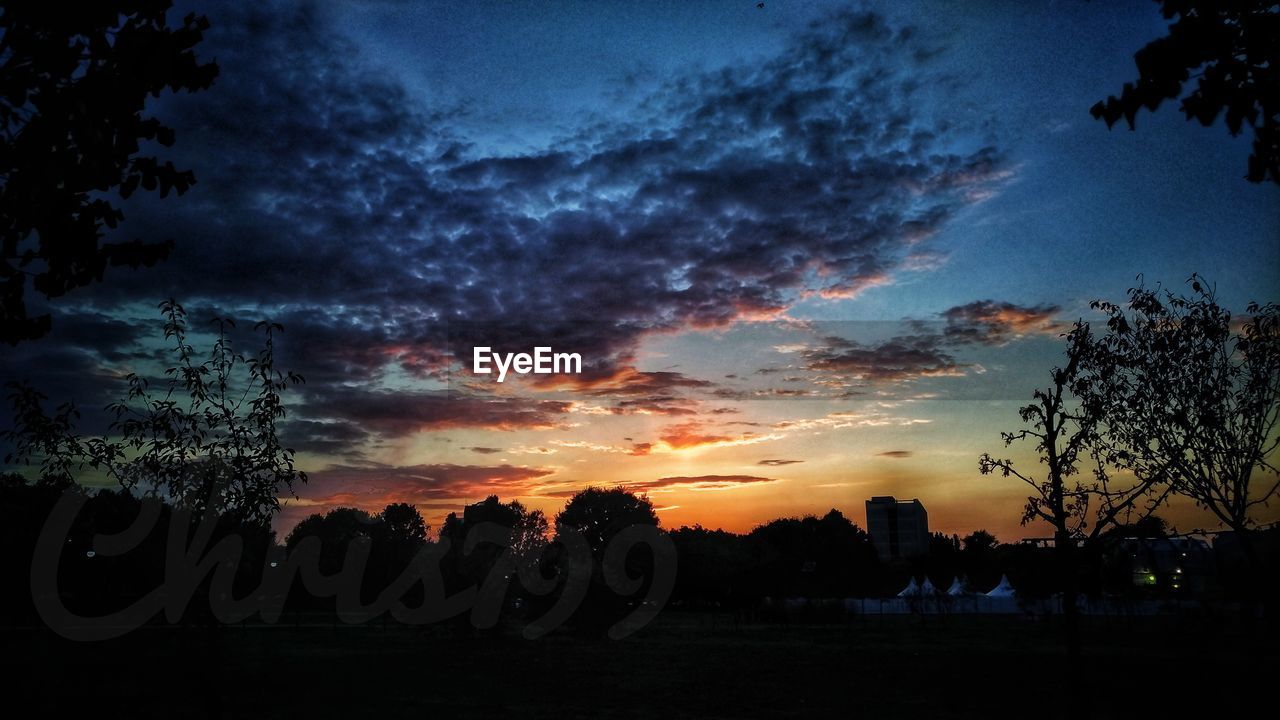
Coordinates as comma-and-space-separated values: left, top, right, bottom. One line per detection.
1073, 275, 1280, 566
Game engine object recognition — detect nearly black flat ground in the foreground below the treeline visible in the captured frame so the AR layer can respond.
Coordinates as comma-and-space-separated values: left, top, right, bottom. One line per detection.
0, 612, 1280, 719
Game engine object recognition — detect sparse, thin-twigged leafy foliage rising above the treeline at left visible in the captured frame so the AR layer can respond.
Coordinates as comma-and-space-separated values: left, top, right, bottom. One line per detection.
5, 300, 306, 521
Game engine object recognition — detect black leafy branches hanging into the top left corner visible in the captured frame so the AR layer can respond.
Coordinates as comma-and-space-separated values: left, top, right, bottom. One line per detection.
0, 0, 218, 345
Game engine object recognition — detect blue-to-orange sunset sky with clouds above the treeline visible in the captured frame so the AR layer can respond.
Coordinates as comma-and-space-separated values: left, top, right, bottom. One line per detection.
5, 0, 1280, 541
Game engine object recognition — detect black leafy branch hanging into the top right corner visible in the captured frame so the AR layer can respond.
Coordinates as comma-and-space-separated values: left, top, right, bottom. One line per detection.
1089, 0, 1280, 183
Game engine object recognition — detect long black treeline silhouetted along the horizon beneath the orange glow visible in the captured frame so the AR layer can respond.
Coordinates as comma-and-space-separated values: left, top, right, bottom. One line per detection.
0, 474, 1259, 632
